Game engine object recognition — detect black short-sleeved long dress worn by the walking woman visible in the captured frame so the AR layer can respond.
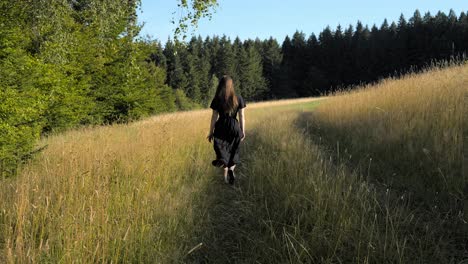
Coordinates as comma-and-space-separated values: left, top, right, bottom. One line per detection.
210, 95, 246, 167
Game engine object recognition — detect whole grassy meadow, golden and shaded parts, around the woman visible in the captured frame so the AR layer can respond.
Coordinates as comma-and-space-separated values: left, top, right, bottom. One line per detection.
0, 65, 468, 263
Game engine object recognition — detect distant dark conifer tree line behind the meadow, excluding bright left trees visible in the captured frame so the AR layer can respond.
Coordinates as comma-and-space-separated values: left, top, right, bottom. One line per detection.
160, 10, 468, 101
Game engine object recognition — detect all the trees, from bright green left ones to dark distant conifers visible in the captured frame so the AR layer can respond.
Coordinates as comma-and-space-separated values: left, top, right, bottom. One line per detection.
0, 0, 468, 178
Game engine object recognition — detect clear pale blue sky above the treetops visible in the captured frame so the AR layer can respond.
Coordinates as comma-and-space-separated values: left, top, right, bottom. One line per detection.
139, 0, 468, 43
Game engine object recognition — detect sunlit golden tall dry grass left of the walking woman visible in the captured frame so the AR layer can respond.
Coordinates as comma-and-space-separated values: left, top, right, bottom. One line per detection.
0, 99, 322, 263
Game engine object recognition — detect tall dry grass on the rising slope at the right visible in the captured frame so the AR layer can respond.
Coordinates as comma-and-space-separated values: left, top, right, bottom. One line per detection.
302, 64, 468, 263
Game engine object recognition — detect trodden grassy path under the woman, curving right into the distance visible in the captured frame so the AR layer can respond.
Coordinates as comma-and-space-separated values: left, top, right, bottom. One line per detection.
184, 102, 328, 263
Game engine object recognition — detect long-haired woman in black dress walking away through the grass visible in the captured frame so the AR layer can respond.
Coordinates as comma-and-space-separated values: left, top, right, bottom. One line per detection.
208, 75, 246, 184
